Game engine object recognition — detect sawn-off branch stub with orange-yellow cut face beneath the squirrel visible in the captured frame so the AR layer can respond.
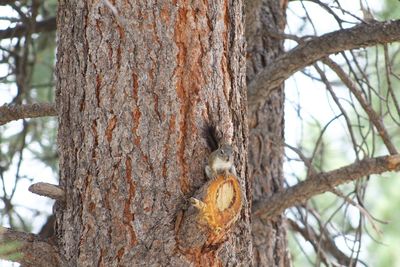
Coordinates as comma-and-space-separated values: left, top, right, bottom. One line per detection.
177, 174, 243, 255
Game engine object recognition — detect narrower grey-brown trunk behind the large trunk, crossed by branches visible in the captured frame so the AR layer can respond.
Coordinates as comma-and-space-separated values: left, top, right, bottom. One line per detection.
246, 0, 290, 266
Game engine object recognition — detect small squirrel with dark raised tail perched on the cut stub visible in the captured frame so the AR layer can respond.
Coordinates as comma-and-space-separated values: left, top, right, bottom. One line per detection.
205, 126, 236, 179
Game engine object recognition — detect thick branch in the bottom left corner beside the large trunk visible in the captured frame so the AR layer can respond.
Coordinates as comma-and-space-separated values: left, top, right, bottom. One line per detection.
0, 226, 62, 266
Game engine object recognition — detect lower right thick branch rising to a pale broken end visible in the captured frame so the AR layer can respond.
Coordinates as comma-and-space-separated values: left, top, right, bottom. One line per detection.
253, 155, 400, 219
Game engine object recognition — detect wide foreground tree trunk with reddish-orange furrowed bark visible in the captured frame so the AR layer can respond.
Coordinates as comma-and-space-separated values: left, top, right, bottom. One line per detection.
56, 0, 252, 266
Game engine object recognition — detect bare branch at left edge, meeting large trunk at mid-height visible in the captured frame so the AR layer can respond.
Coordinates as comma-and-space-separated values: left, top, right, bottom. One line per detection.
0, 103, 57, 125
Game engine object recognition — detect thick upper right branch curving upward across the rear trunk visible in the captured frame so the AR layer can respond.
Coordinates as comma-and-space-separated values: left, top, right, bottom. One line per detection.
248, 20, 400, 107
